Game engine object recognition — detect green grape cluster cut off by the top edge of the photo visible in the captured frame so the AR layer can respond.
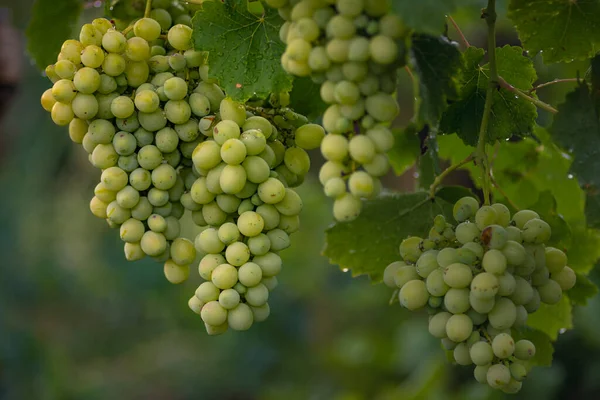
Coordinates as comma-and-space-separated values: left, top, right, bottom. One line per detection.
266, 0, 406, 221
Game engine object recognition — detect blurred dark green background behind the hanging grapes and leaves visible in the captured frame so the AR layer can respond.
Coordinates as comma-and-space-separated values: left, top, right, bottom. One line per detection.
0, 0, 600, 400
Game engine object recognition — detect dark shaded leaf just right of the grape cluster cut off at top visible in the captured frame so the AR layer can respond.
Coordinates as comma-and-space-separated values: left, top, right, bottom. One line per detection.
411, 34, 462, 126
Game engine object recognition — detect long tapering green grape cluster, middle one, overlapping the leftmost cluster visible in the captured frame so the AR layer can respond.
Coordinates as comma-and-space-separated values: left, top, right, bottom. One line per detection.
188, 99, 325, 335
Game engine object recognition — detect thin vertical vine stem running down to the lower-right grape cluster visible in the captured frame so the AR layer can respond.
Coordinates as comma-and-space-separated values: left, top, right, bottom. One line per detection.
475, 0, 500, 205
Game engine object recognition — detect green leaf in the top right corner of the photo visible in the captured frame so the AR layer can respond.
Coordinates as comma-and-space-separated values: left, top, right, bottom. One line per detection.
508, 0, 600, 63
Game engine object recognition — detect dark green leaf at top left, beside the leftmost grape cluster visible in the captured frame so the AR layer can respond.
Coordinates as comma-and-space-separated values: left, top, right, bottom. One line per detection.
26, 0, 83, 69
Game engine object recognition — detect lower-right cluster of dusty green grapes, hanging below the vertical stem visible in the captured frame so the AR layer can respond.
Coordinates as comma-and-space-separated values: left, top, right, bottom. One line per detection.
384, 197, 576, 393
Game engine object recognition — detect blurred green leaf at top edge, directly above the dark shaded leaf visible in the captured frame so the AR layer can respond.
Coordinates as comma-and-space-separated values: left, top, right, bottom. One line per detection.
392, 0, 472, 35
